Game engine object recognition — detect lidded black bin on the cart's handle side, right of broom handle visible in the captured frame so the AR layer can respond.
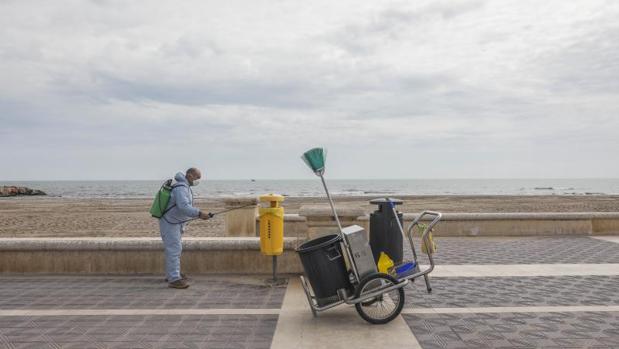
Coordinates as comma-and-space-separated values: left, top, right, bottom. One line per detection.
370, 198, 404, 265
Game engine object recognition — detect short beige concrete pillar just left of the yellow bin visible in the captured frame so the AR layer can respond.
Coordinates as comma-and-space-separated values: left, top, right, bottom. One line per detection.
224, 198, 258, 237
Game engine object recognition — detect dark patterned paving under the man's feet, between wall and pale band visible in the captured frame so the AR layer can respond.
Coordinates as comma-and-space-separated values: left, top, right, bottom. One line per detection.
0, 276, 286, 309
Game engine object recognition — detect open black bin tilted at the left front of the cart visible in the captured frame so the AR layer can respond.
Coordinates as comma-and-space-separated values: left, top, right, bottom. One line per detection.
297, 234, 352, 306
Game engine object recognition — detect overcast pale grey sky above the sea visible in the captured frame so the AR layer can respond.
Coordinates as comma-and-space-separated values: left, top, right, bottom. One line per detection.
0, 0, 619, 180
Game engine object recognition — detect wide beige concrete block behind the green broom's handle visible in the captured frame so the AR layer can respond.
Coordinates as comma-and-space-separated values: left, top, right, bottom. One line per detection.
299, 204, 364, 239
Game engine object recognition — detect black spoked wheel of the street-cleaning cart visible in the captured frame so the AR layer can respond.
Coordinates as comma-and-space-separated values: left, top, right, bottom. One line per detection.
355, 274, 404, 324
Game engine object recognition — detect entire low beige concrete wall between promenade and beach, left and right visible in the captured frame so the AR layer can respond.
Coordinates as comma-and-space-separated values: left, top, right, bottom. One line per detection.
0, 209, 619, 274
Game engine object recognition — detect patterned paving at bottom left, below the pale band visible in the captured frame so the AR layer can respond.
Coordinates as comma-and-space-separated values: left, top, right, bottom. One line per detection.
0, 315, 278, 349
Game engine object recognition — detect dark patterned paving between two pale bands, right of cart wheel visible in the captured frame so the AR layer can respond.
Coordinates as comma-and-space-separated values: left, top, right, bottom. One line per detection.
405, 276, 619, 308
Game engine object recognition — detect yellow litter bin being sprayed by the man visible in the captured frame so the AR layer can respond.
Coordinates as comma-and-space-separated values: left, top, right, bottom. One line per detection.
258, 194, 284, 256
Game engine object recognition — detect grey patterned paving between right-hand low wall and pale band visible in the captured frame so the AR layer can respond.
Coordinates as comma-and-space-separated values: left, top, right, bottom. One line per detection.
404, 236, 619, 264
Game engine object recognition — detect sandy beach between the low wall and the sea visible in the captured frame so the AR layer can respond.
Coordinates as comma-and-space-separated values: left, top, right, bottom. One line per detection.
0, 196, 619, 237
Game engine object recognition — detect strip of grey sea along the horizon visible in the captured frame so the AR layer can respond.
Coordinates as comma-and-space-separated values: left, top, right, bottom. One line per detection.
0, 178, 619, 198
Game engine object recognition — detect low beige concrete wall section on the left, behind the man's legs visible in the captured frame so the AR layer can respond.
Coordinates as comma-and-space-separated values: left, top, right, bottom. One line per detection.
0, 237, 301, 274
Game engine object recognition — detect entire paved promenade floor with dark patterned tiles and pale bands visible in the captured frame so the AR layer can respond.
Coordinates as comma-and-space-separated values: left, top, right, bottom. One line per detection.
0, 237, 619, 349
